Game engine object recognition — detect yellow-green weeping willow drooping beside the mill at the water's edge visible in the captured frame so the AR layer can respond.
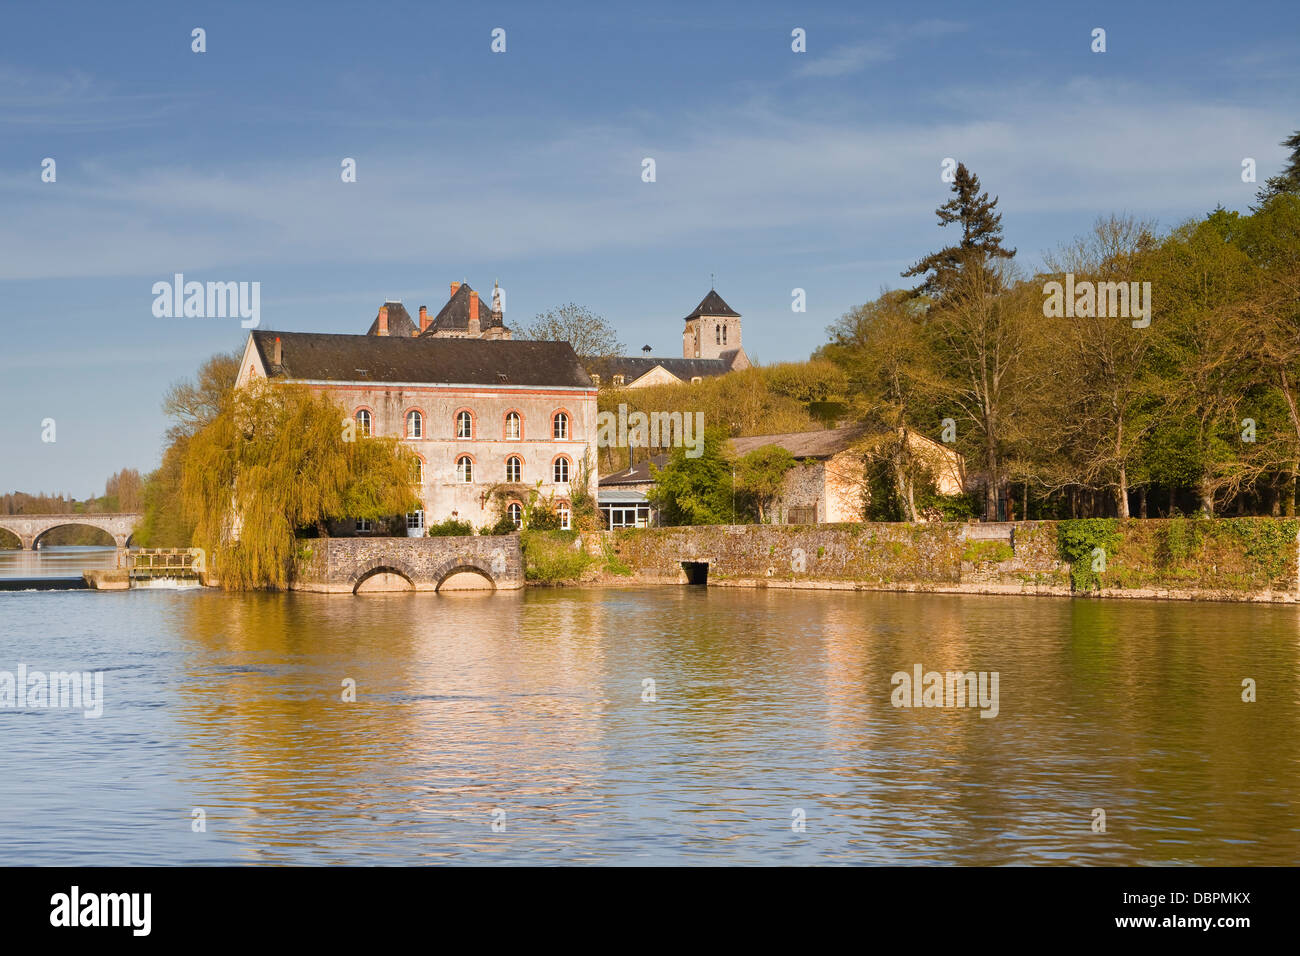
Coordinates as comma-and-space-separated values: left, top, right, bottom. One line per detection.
181, 382, 420, 591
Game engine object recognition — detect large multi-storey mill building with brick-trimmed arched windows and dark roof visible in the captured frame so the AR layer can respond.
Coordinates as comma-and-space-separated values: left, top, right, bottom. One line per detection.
238, 284, 597, 535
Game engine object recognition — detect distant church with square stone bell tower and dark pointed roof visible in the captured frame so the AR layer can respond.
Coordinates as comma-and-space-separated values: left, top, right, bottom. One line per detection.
590, 289, 750, 389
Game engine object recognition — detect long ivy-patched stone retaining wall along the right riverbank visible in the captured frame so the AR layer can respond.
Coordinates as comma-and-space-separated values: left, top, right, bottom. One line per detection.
599, 518, 1300, 604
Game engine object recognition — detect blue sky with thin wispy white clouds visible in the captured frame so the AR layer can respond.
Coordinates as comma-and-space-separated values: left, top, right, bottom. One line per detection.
0, 0, 1300, 497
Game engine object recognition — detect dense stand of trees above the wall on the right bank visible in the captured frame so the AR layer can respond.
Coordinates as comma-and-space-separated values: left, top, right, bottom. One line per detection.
815, 134, 1300, 518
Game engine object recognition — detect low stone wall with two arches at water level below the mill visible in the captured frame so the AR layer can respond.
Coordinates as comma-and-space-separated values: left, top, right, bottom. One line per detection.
290, 535, 524, 594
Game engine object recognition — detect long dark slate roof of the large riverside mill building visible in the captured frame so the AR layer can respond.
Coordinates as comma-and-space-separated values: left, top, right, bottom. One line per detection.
250, 330, 592, 389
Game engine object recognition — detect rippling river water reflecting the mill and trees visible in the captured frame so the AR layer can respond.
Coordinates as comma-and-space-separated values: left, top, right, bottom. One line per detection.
0, 554, 1300, 865
